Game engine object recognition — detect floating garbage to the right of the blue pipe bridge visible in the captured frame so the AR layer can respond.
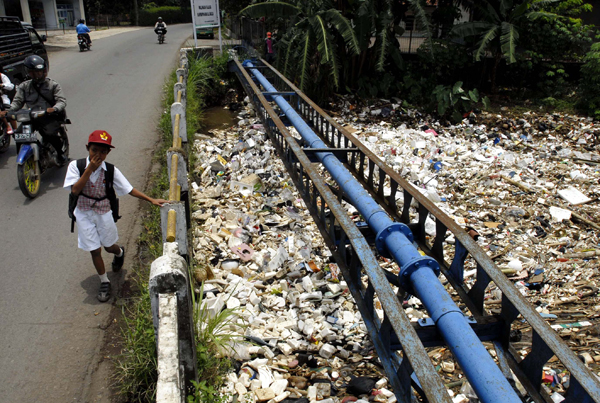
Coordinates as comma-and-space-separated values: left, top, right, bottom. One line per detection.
331, 97, 600, 402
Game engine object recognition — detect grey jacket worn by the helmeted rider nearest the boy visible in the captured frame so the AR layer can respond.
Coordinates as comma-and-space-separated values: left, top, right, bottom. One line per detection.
8, 77, 67, 112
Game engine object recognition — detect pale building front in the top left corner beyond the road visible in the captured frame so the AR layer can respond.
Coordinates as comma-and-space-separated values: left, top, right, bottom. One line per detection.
0, 0, 85, 29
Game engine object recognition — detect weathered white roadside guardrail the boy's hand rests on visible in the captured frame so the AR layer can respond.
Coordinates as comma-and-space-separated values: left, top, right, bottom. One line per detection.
149, 49, 197, 403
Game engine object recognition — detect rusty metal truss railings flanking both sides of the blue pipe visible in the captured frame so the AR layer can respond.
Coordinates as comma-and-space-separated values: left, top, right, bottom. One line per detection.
230, 54, 600, 403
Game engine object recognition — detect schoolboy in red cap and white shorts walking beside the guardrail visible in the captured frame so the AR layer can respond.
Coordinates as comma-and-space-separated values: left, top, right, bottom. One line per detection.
64, 130, 168, 302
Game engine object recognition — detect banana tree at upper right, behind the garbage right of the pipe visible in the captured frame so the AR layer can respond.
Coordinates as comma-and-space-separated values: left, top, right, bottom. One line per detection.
451, 0, 561, 92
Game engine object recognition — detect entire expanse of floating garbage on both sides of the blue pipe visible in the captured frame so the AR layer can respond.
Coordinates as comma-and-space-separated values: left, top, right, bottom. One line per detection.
192, 97, 600, 403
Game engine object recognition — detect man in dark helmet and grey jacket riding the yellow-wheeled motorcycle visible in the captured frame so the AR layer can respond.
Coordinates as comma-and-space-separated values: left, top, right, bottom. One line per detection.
0, 55, 67, 165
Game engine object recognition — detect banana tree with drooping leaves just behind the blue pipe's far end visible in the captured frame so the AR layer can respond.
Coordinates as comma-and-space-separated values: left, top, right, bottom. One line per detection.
240, 0, 359, 90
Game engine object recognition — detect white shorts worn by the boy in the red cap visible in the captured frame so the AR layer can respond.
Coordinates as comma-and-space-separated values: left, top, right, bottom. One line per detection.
74, 208, 119, 252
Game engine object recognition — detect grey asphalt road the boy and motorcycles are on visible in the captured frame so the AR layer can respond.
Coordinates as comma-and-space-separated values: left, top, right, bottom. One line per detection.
0, 25, 191, 403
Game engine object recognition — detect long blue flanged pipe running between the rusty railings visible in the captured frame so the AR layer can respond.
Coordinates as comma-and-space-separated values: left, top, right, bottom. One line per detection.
243, 60, 521, 403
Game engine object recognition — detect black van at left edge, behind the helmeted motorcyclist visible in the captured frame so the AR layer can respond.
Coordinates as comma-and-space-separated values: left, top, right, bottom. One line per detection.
0, 17, 50, 84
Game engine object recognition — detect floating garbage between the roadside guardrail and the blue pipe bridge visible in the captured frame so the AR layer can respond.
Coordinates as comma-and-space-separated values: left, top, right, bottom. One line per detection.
192, 109, 396, 403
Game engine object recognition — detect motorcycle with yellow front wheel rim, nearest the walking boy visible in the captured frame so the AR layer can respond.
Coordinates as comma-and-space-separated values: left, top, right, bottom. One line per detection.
11, 109, 71, 199
